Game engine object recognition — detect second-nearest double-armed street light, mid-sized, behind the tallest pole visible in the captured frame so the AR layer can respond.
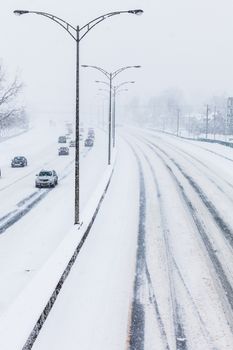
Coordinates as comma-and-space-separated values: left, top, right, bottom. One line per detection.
82, 64, 141, 165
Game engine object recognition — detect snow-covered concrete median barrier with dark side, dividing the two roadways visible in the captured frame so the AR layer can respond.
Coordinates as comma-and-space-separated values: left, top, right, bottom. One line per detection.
0, 162, 115, 350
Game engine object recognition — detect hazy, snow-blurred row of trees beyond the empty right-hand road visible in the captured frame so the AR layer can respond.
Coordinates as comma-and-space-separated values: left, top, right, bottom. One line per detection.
126, 89, 232, 138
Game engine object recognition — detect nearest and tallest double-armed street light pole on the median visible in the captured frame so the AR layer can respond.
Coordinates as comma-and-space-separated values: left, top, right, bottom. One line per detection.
14, 9, 143, 224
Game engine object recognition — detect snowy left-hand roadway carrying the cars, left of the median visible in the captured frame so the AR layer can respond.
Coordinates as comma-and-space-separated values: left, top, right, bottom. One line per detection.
0, 128, 107, 315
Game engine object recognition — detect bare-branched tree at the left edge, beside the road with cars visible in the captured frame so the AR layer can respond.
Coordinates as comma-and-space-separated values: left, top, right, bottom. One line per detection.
0, 63, 28, 136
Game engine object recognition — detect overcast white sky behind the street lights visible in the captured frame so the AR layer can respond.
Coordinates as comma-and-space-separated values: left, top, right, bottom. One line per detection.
0, 0, 233, 121
